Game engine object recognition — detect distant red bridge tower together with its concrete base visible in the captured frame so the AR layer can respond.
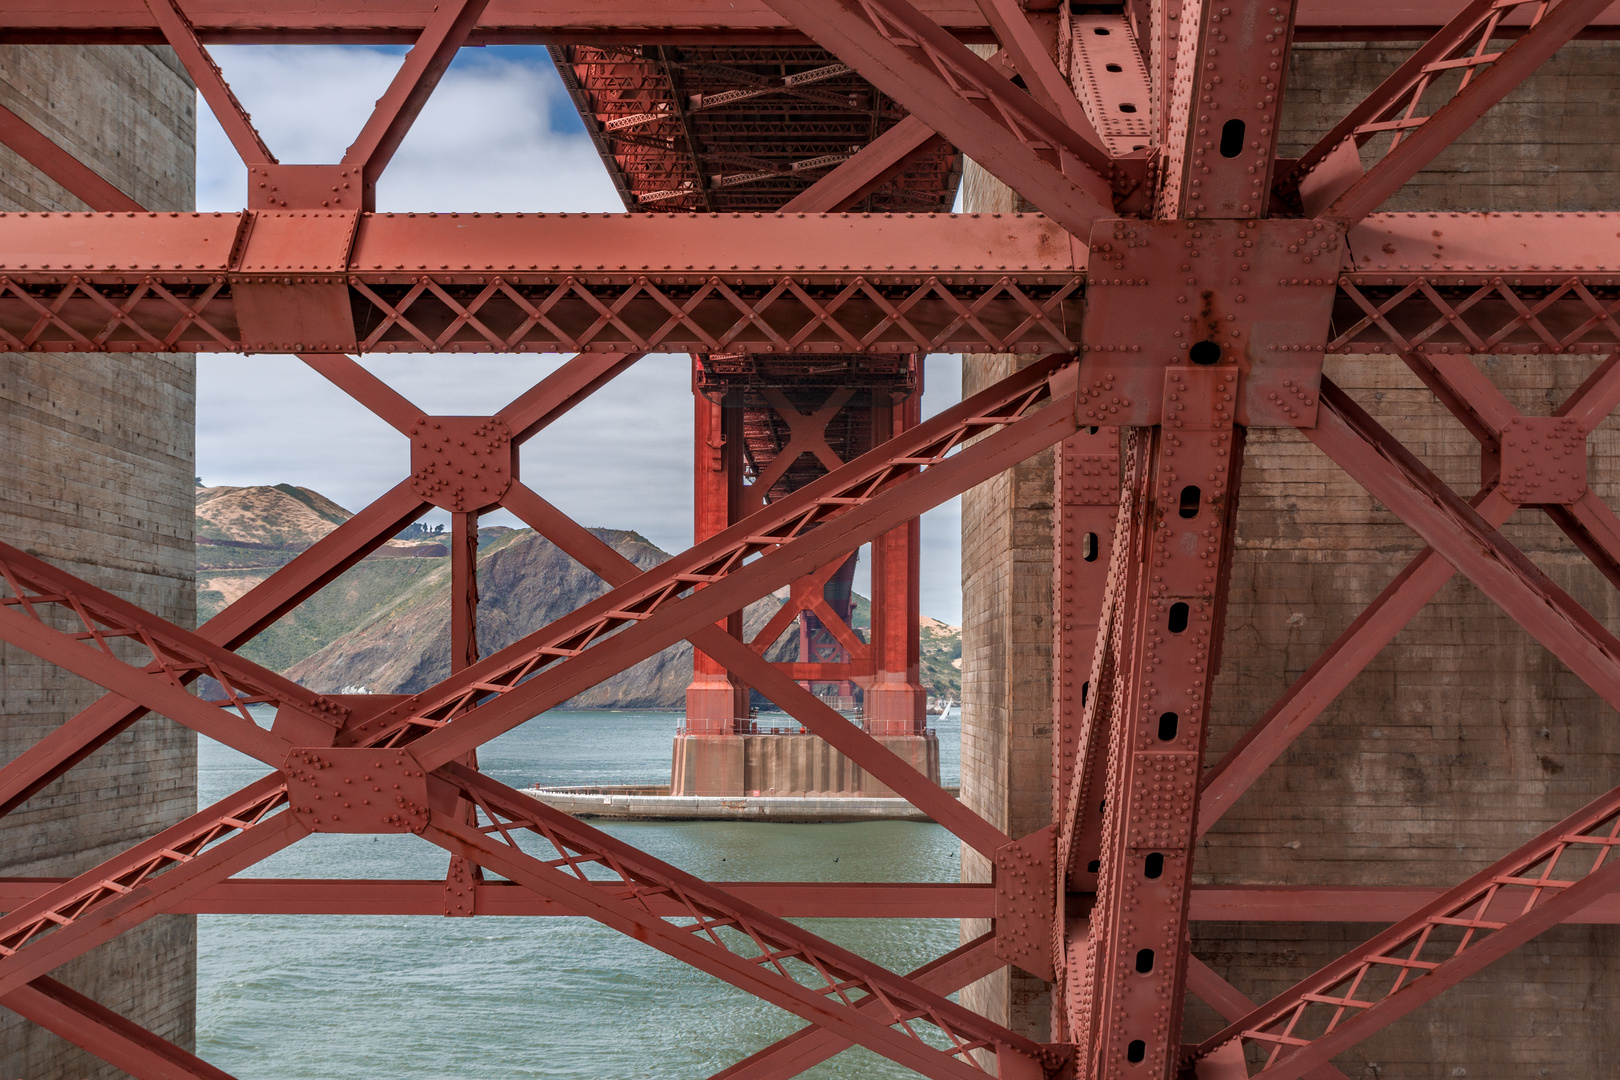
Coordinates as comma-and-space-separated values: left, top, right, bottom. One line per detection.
671, 353, 940, 797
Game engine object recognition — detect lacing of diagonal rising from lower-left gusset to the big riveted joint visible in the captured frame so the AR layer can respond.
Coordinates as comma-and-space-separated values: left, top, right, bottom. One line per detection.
348, 356, 1072, 746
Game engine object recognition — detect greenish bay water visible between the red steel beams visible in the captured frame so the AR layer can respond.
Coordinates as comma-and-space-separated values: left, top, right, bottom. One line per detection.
198, 709, 961, 1080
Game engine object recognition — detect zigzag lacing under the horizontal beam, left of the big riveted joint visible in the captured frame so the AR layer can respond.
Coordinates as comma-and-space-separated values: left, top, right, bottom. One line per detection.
0, 274, 1084, 353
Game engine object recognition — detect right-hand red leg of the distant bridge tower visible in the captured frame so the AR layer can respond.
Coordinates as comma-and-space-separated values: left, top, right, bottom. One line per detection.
865, 385, 928, 735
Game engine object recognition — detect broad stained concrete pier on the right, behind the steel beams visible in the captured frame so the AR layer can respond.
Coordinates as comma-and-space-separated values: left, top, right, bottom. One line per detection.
961, 40, 1620, 1080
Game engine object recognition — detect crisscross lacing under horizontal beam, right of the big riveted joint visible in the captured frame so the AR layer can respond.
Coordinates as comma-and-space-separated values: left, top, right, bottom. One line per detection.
1327, 275, 1620, 353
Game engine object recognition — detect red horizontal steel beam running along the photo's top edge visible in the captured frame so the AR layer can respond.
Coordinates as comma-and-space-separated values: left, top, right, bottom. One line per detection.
12, 0, 1620, 45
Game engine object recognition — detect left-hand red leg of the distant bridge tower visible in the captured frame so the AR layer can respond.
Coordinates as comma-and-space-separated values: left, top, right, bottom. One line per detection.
687, 365, 748, 735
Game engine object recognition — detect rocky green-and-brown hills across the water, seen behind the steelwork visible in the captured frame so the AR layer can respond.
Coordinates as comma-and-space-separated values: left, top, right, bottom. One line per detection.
198, 484, 961, 709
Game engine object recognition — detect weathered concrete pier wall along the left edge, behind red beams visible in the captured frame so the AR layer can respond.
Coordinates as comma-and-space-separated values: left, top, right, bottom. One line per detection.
0, 45, 196, 1080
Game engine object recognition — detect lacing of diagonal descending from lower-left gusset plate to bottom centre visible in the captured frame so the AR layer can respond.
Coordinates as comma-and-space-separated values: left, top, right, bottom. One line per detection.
450, 787, 1017, 1070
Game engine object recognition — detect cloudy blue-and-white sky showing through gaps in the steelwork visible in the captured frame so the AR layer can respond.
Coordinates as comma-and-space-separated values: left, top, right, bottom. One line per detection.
198, 45, 962, 625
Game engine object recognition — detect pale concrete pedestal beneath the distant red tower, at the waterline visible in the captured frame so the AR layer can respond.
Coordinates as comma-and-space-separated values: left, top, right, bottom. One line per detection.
669, 732, 940, 798
